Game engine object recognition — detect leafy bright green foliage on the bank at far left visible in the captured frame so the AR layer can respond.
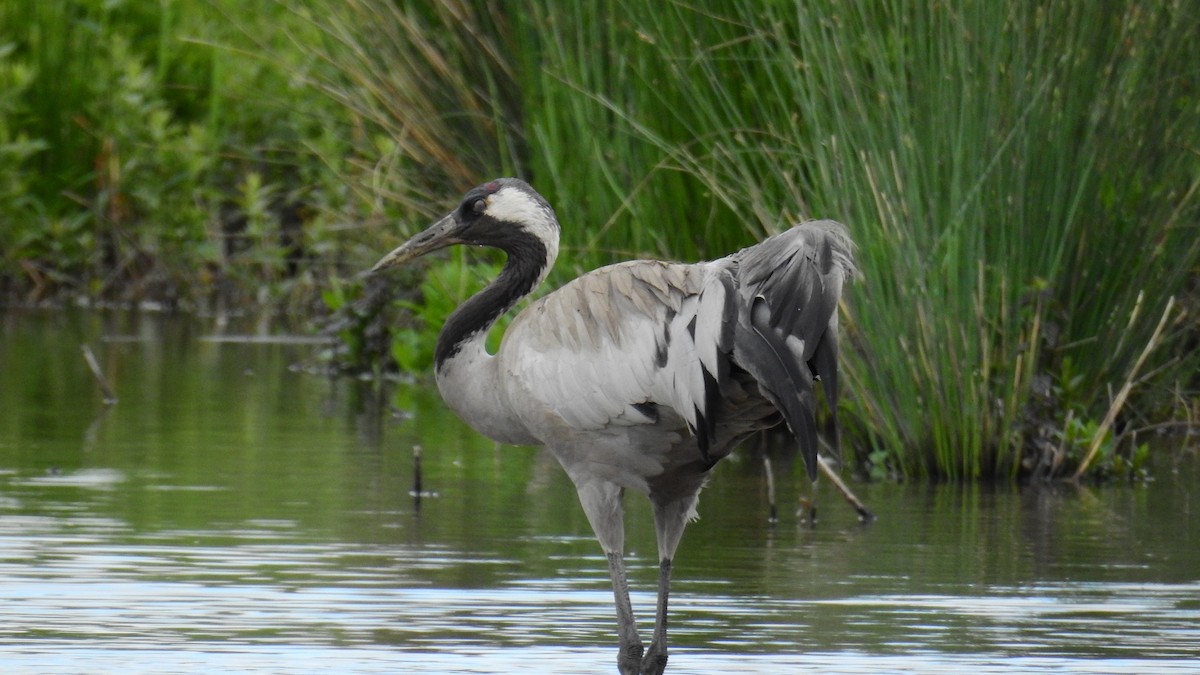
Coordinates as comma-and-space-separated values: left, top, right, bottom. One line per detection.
0, 0, 348, 306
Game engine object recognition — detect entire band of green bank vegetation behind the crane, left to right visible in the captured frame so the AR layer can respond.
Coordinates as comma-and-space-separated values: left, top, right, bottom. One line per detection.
0, 0, 1200, 480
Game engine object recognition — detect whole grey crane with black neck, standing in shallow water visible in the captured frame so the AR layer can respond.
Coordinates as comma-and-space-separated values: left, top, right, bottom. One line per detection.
374, 179, 854, 675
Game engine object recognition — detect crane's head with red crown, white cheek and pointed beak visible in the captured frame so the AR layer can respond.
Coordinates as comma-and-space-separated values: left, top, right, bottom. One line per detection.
371, 178, 558, 273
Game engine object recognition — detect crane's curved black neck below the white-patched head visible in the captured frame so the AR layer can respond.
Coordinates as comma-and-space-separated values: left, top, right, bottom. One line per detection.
433, 234, 548, 370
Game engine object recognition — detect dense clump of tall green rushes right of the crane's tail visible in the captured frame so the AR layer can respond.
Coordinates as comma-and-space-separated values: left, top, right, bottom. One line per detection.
604, 2, 1200, 477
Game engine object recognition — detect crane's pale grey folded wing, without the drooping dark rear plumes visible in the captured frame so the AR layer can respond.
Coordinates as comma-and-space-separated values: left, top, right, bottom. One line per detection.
498, 261, 736, 443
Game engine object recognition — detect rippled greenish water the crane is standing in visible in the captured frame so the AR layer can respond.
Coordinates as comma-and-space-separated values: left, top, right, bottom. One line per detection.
0, 313, 1200, 674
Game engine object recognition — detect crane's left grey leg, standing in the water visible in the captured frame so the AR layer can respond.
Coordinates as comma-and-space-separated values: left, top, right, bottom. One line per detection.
575, 480, 644, 675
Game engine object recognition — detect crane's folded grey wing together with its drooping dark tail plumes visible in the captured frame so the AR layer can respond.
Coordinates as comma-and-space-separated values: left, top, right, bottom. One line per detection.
498, 221, 854, 476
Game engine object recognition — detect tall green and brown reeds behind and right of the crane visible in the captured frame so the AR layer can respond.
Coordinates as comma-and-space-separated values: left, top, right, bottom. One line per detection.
302, 0, 1200, 478
